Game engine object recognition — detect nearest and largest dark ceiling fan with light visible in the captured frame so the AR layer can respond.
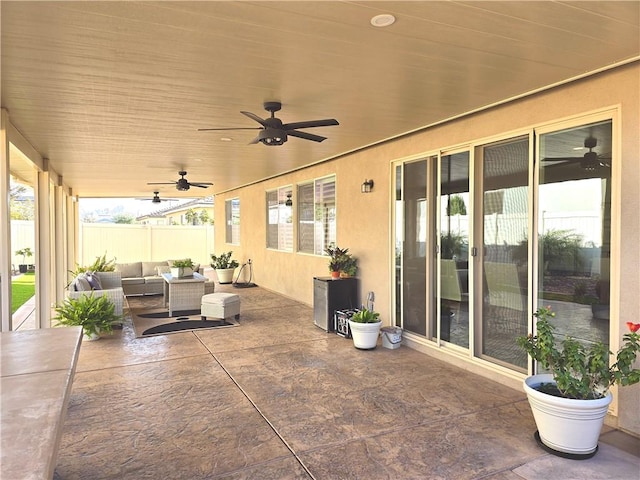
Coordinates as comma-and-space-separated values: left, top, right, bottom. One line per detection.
198, 102, 340, 146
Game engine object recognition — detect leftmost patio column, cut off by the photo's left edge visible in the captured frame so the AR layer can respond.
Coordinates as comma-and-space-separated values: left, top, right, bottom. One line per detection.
0, 108, 11, 332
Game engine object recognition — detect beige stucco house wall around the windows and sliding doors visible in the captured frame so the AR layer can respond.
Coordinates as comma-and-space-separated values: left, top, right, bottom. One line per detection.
215, 62, 640, 435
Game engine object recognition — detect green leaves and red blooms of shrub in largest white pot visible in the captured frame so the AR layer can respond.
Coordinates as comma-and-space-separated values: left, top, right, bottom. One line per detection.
516, 307, 640, 400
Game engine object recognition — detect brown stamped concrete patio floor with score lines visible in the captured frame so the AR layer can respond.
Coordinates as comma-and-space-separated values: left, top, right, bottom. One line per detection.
55, 285, 640, 480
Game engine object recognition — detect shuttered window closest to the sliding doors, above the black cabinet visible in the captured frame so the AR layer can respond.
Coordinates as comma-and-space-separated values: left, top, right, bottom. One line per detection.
298, 175, 336, 255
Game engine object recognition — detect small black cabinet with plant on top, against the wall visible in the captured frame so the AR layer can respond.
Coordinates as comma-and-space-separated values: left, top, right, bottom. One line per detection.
313, 277, 360, 332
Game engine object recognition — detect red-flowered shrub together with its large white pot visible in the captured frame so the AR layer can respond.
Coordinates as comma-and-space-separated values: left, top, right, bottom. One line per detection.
517, 307, 640, 459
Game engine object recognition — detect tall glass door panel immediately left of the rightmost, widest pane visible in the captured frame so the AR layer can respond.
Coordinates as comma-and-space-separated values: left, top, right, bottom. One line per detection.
475, 136, 530, 370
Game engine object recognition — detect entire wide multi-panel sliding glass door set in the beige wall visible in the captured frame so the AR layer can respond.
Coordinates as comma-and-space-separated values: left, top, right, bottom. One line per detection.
393, 117, 613, 373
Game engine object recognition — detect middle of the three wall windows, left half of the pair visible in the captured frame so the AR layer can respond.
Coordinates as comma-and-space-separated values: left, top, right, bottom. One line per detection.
267, 186, 293, 252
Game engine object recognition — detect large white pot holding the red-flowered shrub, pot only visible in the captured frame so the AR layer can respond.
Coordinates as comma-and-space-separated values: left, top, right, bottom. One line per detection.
524, 374, 613, 458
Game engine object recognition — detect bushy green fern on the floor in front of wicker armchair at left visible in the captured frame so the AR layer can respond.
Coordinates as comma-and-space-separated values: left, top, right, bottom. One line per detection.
54, 292, 122, 340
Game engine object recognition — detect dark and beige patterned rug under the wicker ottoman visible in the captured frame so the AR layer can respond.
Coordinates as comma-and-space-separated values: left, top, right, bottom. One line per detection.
132, 309, 240, 338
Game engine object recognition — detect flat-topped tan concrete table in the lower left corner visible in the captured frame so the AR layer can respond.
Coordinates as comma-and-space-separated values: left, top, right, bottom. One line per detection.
0, 327, 82, 480
